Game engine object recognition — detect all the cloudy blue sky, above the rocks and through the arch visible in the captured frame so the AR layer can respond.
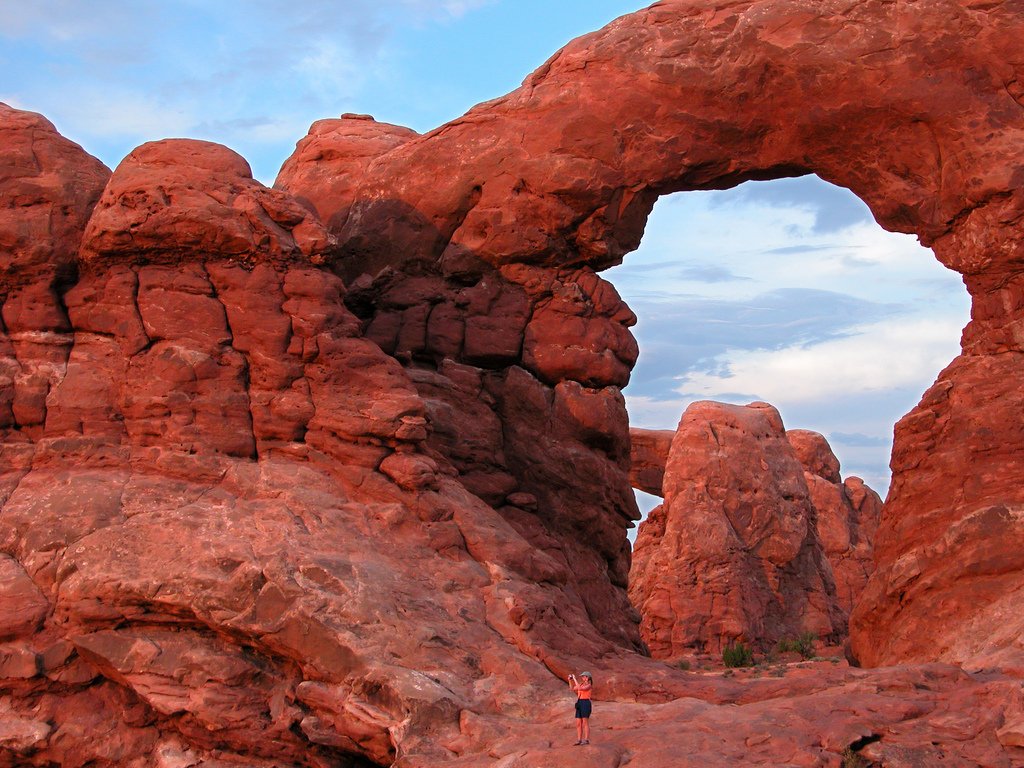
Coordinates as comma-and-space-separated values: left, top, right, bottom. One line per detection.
0, 0, 969, 499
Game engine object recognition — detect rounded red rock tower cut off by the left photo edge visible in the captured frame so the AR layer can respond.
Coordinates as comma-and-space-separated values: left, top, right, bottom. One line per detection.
0, 104, 110, 450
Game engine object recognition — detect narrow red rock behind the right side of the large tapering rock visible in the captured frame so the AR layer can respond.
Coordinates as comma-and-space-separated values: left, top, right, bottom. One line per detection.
785, 429, 882, 615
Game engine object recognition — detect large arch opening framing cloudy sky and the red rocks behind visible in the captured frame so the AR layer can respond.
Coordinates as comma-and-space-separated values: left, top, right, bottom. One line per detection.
602, 176, 967, 659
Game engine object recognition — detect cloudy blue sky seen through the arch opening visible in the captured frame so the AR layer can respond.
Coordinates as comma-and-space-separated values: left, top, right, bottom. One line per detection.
604, 178, 970, 494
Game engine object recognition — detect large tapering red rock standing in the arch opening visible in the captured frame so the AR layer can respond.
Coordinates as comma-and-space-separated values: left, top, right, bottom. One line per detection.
630, 401, 845, 658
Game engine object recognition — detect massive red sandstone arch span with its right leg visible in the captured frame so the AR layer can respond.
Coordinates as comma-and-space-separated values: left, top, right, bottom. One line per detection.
278, 0, 1024, 664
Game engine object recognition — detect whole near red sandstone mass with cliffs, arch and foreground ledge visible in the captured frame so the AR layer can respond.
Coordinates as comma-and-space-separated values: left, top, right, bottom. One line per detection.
0, 0, 1024, 768
